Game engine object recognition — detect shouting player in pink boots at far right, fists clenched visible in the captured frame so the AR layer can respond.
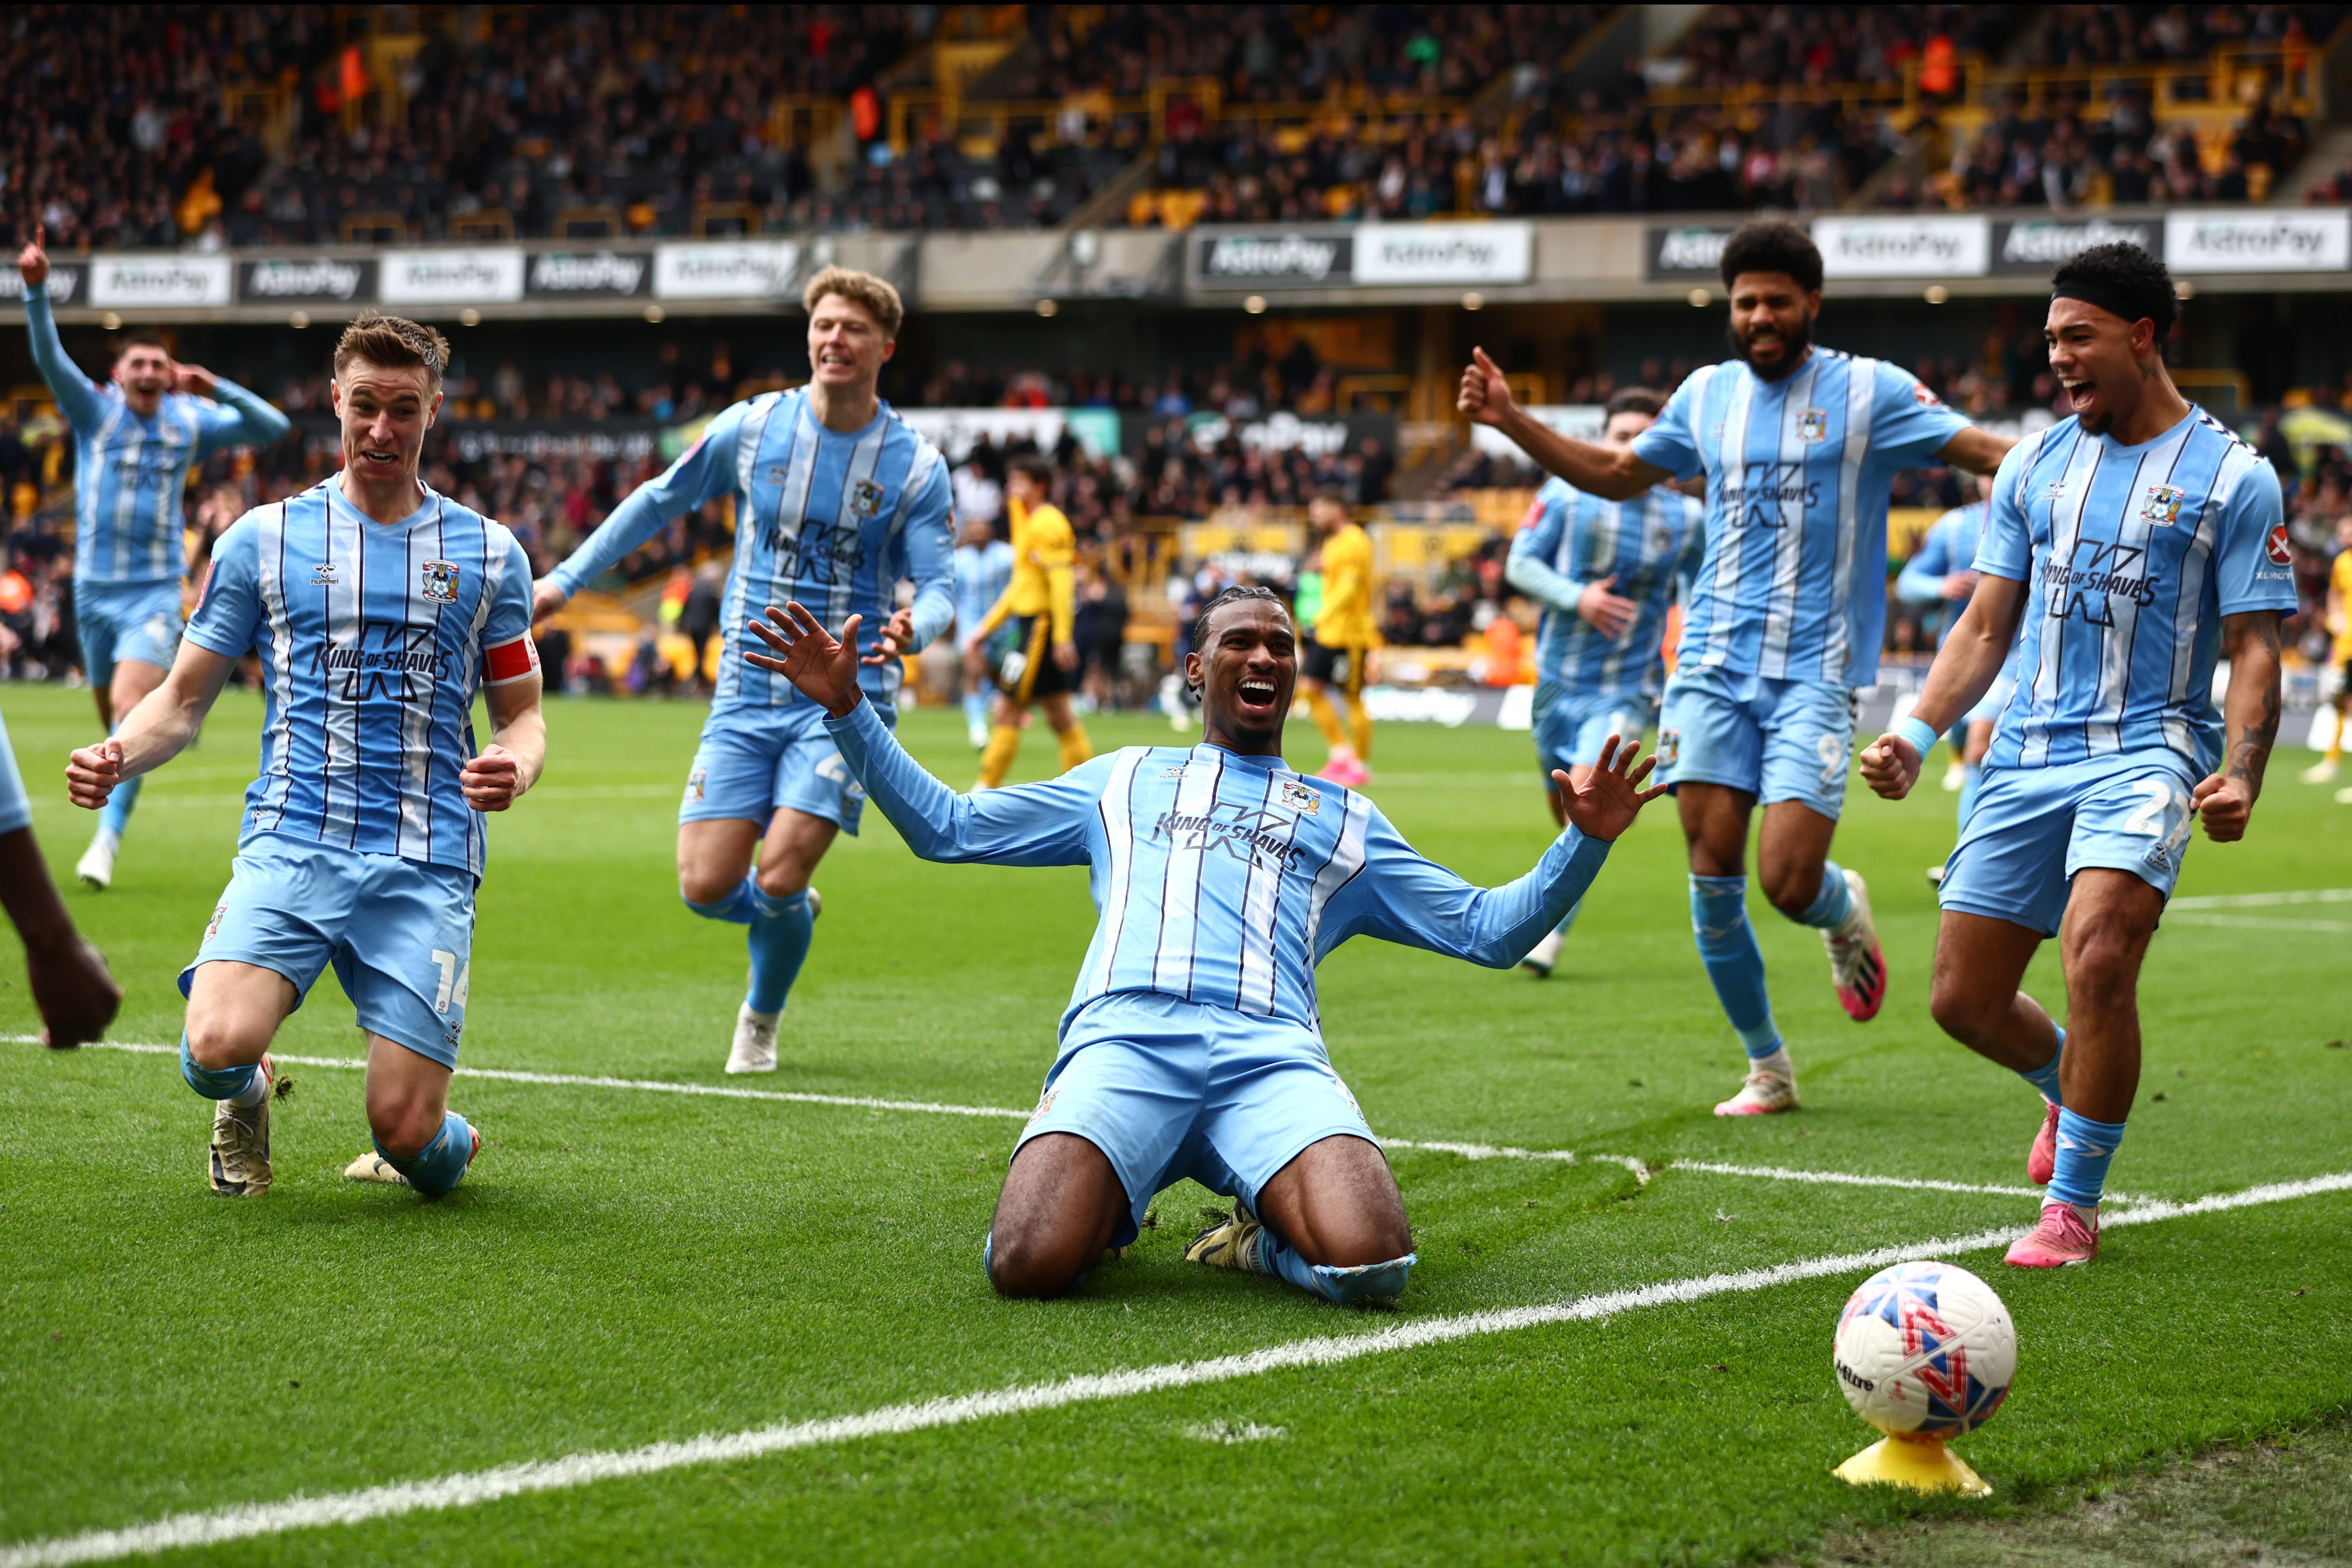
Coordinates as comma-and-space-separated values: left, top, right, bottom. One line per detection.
1863, 244, 2296, 1267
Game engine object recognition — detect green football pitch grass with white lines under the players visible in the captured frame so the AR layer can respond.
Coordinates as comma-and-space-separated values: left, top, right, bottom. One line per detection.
0, 686, 2352, 1563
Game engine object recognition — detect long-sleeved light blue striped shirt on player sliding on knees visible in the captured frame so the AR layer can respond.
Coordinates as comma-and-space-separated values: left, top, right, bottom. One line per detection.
825, 703, 1609, 1030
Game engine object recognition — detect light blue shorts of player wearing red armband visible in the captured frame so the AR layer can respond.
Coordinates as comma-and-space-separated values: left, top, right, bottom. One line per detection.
179, 832, 473, 1067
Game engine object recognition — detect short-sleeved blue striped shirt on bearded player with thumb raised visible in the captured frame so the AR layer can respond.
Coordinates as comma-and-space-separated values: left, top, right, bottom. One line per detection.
1632, 348, 1969, 686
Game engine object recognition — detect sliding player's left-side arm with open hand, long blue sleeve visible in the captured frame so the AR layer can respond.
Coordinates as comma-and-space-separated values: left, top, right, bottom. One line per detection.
743, 604, 1110, 865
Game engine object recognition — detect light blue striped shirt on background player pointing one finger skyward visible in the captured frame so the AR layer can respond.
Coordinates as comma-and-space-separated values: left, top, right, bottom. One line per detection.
23, 284, 294, 583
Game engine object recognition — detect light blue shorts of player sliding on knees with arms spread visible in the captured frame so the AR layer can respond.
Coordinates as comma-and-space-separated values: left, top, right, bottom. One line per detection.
1014, 992, 1381, 1246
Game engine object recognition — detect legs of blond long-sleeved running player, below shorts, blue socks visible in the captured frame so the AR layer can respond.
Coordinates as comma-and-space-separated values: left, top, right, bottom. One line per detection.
677, 806, 840, 1072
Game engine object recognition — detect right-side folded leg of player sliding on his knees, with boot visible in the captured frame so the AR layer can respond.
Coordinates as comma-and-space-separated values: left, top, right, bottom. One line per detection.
1185, 1136, 1414, 1303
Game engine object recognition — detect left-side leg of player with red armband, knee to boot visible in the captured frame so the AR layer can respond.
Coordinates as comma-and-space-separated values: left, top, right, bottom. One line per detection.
179, 959, 301, 1197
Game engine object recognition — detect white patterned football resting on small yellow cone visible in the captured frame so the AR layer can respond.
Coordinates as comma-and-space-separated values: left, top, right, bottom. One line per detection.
1832, 1263, 2018, 1437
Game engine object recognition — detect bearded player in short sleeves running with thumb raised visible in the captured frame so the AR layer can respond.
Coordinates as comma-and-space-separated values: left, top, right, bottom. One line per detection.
1461, 218, 2009, 1117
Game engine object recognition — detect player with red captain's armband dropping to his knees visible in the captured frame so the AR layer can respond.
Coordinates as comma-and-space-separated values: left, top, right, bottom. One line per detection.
66, 313, 548, 1197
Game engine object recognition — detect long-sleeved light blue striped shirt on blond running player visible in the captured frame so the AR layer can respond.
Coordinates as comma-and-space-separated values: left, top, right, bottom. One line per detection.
553, 388, 955, 710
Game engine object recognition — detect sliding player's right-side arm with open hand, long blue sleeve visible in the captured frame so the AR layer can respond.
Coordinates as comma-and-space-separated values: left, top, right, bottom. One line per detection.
1315, 736, 1665, 969
